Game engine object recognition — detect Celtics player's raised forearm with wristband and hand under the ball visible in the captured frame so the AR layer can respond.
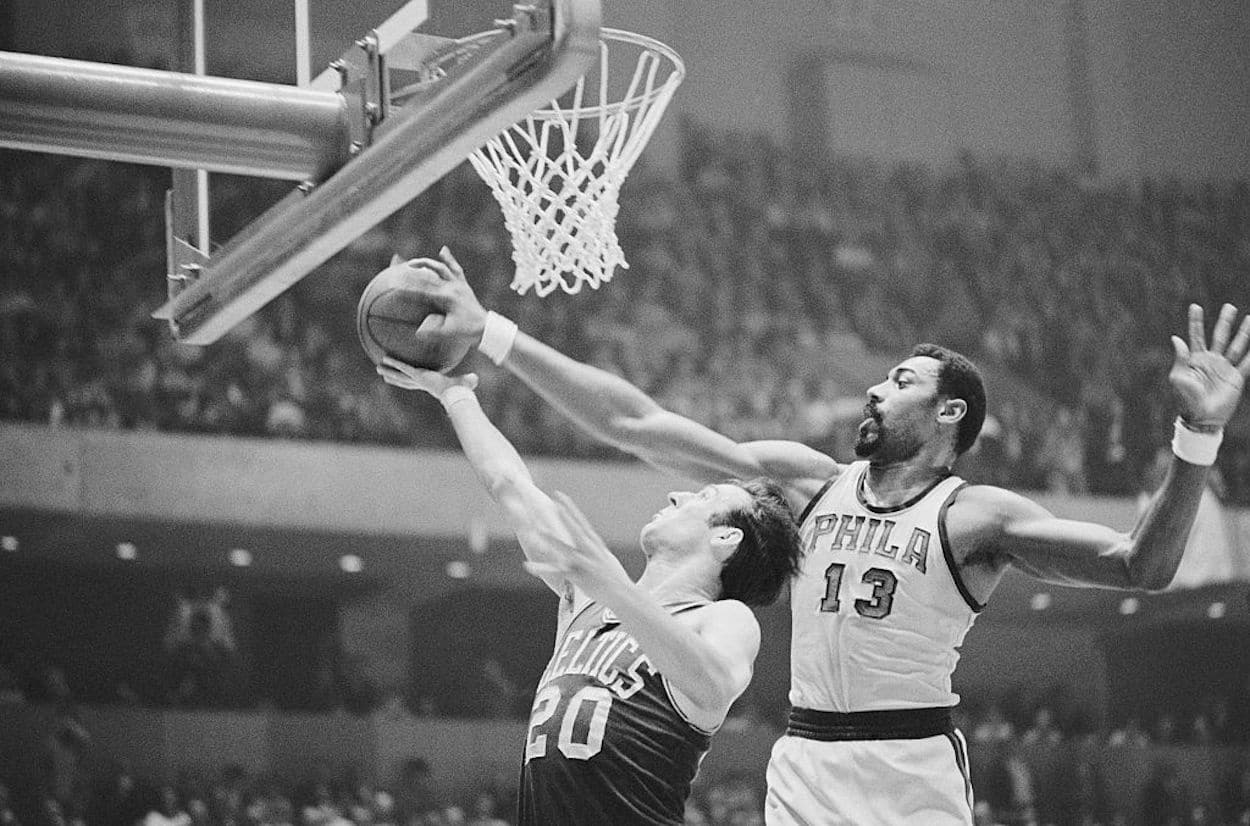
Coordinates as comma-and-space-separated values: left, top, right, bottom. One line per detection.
378, 359, 571, 594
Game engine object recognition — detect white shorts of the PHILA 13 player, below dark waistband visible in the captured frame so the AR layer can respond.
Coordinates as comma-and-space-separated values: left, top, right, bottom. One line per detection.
764, 731, 973, 826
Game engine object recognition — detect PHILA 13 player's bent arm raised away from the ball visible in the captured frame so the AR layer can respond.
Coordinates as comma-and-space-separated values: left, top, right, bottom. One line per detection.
965, 305, 1250, 590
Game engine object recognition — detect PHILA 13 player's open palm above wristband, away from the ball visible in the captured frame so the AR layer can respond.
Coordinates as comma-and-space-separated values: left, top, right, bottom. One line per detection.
1168, 304, 1250, 427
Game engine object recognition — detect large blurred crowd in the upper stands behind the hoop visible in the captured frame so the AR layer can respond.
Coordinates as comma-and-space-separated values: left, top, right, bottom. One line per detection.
0, 117, 1250, 502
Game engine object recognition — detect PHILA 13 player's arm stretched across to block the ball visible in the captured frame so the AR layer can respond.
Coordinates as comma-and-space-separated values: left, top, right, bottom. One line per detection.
397, 247, 839, 506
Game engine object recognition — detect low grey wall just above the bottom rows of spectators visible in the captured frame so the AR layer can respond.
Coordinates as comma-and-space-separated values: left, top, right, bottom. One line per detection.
0, 706, 1244, 822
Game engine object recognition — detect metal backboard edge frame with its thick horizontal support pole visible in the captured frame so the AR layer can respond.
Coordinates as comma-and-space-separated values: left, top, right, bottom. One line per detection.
0, 0, 600, 345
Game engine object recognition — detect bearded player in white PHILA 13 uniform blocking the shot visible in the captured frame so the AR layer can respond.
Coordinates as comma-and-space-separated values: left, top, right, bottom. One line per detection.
395, 247, 1250, 826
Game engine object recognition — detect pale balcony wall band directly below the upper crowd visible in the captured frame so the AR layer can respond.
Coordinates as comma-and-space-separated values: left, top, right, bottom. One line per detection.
0, 422, 1220, 549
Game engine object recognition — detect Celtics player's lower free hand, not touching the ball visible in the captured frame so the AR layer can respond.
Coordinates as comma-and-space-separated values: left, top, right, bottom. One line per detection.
525, 491, 630, 601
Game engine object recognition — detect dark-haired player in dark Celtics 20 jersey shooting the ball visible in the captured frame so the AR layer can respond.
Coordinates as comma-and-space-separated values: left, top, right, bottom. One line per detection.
378, 359, 800, 826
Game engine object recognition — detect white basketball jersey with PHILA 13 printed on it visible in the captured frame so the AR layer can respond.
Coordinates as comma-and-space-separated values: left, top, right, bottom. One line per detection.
790, 461, 984, 712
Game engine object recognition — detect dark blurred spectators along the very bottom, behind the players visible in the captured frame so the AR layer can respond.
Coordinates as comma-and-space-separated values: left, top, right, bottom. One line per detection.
0, 704, 1250, 826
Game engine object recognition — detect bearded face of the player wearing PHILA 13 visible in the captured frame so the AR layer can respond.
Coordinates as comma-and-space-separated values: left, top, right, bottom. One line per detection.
855, 356, 941, 465
